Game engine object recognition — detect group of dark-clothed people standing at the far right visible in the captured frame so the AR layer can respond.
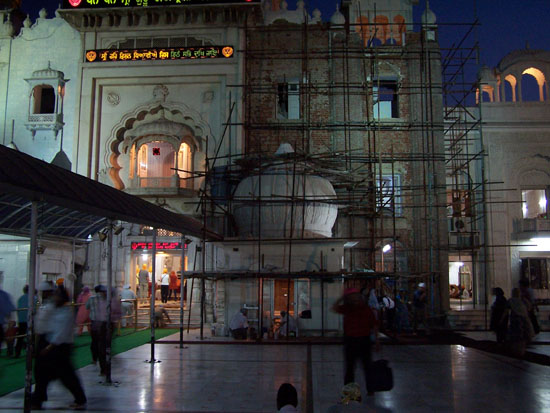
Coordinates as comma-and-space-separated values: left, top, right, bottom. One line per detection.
491, 278, 540, 356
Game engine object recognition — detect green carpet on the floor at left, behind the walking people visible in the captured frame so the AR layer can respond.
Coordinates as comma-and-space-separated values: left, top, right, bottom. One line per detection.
0, 328, 179, 396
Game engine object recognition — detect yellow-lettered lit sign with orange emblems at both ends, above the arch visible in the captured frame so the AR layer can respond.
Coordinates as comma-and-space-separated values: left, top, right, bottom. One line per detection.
86, 46, 234, 63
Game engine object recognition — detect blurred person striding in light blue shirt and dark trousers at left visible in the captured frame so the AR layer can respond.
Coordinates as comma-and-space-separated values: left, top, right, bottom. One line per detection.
31, 286, 87, 410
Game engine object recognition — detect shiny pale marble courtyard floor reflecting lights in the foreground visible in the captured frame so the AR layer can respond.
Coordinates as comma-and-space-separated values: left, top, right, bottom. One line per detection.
0, 335, 550, 413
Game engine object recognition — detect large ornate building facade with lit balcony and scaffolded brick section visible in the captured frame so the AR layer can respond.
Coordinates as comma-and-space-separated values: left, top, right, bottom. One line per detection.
0, 0, 449, 333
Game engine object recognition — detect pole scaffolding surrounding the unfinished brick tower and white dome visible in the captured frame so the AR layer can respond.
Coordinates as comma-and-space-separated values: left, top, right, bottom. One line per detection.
174, 3, 488, 337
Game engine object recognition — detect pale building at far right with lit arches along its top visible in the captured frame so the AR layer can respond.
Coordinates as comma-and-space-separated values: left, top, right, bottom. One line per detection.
480, 49, 550, 300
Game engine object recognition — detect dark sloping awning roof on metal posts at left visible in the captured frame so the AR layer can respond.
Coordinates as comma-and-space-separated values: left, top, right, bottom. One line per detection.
0, 145, 221, 240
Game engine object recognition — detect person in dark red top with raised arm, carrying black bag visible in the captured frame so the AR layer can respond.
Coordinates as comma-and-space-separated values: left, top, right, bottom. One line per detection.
332, 288, 379, 395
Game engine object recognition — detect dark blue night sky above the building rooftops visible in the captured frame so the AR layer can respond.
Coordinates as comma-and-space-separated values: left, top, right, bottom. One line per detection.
19, 0, 550, 66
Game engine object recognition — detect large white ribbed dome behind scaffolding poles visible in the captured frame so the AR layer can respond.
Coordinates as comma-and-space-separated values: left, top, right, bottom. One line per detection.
233, 168, 338, 238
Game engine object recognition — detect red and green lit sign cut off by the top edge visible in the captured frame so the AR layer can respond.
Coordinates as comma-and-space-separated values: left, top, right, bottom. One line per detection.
63, 0, 260, 10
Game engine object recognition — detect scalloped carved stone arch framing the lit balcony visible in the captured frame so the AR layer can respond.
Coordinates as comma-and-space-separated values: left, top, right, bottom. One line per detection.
104, 102, 216, 189
